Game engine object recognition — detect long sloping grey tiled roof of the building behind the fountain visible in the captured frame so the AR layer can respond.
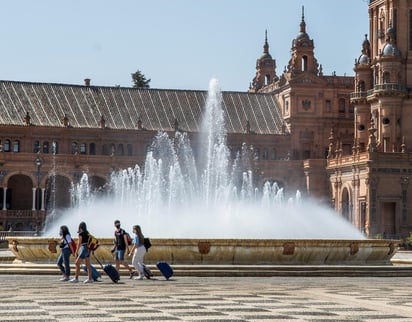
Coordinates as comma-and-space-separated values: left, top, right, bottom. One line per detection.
0, 81, 282, 134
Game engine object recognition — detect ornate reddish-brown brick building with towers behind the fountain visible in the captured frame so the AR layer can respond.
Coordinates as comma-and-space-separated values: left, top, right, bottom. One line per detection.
0, 0, 412, 238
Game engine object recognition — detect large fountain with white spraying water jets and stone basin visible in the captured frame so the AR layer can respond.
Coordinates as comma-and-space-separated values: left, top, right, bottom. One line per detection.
9, 80, 396, 264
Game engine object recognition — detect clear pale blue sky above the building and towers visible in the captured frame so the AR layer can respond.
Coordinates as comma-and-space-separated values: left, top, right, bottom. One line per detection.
0, 0, 369, 91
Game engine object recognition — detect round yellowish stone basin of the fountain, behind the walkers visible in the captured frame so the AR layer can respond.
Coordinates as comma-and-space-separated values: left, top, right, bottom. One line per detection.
7, 237, 399, 265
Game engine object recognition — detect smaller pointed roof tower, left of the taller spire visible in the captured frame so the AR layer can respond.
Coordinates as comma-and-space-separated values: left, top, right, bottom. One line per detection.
249, 30, 277, 93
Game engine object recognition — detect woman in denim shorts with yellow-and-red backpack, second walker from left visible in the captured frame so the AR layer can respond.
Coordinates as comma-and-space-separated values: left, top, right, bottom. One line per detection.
70, 221, 93, 283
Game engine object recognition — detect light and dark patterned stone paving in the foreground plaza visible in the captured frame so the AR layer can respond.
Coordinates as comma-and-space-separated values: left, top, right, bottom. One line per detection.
0, 275, 412, 322
